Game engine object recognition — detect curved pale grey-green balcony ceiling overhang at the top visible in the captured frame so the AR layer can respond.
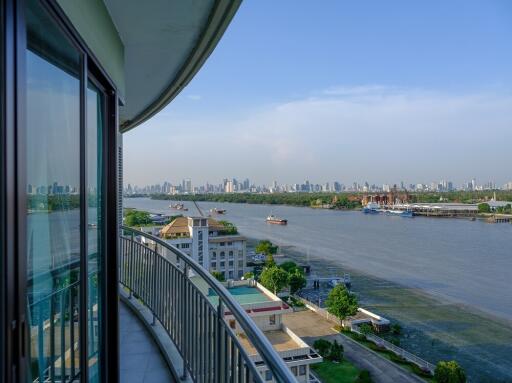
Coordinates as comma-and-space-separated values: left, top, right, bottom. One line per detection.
104, 0, 241, 132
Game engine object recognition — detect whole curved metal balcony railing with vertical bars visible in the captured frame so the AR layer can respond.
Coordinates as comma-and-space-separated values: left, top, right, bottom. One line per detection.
119, 226, 296, 382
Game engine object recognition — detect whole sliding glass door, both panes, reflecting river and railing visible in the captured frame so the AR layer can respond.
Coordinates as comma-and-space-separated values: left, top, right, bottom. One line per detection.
20, 0, 107, 383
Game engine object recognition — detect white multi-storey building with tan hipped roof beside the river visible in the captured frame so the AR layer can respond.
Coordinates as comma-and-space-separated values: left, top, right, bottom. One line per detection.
159, 217, 247, 279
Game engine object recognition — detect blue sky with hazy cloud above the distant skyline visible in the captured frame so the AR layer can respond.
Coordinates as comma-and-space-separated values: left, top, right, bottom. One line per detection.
123, 0, 512, 186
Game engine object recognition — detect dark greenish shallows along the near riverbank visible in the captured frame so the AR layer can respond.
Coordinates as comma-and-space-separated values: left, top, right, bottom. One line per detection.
249, 239, 512, 382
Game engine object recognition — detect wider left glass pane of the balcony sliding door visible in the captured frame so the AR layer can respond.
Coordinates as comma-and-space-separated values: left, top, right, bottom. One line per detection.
23, 0, 82, 382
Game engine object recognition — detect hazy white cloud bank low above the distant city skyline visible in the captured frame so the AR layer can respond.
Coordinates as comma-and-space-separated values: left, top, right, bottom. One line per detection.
126, 85, 512, 183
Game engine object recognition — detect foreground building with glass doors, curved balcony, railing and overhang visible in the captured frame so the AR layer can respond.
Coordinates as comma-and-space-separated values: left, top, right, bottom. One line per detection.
0, 0, 296, 383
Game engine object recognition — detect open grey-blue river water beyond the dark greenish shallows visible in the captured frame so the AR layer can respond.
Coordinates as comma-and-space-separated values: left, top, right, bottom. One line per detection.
124, 198, 512, 320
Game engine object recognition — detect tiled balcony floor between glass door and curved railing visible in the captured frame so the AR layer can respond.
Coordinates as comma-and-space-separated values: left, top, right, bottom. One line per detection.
119, 303, 175, 383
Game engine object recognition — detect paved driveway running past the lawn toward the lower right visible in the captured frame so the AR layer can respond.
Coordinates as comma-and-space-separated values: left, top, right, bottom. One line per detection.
283, 310, 425, 383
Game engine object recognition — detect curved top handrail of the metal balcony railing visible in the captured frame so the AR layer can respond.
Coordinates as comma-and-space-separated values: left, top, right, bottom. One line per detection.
121, 225, 296, 382
